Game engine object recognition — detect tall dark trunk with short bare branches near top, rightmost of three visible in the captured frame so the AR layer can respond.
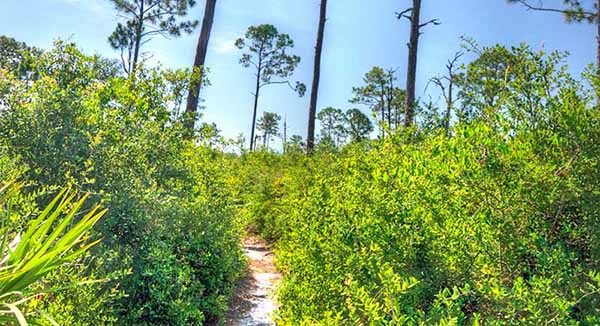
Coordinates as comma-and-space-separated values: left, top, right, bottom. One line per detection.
404, 0, 421, 127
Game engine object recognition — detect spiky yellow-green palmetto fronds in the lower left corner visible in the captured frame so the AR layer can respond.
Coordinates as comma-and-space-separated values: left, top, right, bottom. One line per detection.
0, 183, 106, 325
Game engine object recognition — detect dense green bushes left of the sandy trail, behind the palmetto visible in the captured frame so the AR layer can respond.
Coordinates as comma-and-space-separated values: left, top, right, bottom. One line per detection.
0, 42, 244, 325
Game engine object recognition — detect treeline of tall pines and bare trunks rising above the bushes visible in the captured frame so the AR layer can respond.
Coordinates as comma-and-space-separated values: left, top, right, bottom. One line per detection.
28, 0, 600, 152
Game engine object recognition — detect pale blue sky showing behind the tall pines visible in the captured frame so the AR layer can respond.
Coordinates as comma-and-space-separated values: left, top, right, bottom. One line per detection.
0, 0, 596, 145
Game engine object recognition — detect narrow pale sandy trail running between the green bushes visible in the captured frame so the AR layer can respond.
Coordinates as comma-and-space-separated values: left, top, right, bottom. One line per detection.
225, 237, 281, 326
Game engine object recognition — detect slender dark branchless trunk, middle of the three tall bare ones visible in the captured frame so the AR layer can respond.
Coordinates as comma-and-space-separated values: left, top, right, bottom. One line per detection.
306, 0, 327, 153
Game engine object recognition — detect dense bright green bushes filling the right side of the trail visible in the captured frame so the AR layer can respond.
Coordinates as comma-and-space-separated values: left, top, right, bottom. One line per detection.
233, 48, 600, 325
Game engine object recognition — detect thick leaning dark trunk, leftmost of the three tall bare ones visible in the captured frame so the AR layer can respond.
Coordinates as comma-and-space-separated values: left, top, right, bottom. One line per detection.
184, 0, 217, 135
